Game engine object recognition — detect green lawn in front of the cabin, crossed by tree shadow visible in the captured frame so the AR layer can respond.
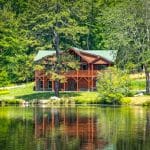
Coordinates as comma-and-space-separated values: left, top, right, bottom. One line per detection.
0, 83, 98, 104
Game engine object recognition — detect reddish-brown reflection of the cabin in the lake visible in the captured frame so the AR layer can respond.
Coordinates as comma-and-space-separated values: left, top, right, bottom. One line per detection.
34, 109, 107, 150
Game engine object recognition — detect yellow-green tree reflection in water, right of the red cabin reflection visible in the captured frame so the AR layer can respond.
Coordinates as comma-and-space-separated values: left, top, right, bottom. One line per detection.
98, 107, 150, 150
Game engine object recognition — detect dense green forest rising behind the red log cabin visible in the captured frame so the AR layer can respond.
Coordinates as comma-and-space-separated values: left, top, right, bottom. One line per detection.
0, 0, 150, 86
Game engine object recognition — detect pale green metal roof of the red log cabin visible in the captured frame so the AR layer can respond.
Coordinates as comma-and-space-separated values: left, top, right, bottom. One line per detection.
34, 47, 117, 62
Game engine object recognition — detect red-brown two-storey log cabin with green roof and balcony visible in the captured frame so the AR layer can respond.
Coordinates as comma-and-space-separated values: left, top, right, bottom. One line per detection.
34, 48, 117, 91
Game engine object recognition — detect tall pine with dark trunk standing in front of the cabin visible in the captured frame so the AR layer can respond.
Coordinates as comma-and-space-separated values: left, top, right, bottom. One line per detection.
26, 0, 87, 96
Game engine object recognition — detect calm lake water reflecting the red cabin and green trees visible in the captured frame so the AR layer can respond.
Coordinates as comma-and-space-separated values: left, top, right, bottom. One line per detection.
0, 106, 150, 150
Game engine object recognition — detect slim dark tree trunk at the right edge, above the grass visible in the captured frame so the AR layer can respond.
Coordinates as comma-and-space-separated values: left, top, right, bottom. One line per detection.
144, 65, 150, 94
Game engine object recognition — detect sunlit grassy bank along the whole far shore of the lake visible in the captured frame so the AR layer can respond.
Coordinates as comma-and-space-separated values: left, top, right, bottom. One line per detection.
0, 78, 150, 105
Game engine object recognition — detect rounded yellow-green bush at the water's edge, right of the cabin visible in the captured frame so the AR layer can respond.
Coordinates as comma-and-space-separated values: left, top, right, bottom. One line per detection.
97, 68, 130, 104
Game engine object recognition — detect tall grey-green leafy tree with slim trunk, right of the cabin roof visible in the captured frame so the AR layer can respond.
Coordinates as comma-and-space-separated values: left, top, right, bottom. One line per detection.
100, 0, 150, 93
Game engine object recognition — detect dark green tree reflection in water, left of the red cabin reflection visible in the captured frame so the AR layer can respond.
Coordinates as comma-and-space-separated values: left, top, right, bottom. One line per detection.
0, 118, 35, 150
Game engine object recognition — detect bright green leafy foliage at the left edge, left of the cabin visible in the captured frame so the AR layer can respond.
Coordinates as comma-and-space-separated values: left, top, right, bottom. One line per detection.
0, 3, 33, 86
